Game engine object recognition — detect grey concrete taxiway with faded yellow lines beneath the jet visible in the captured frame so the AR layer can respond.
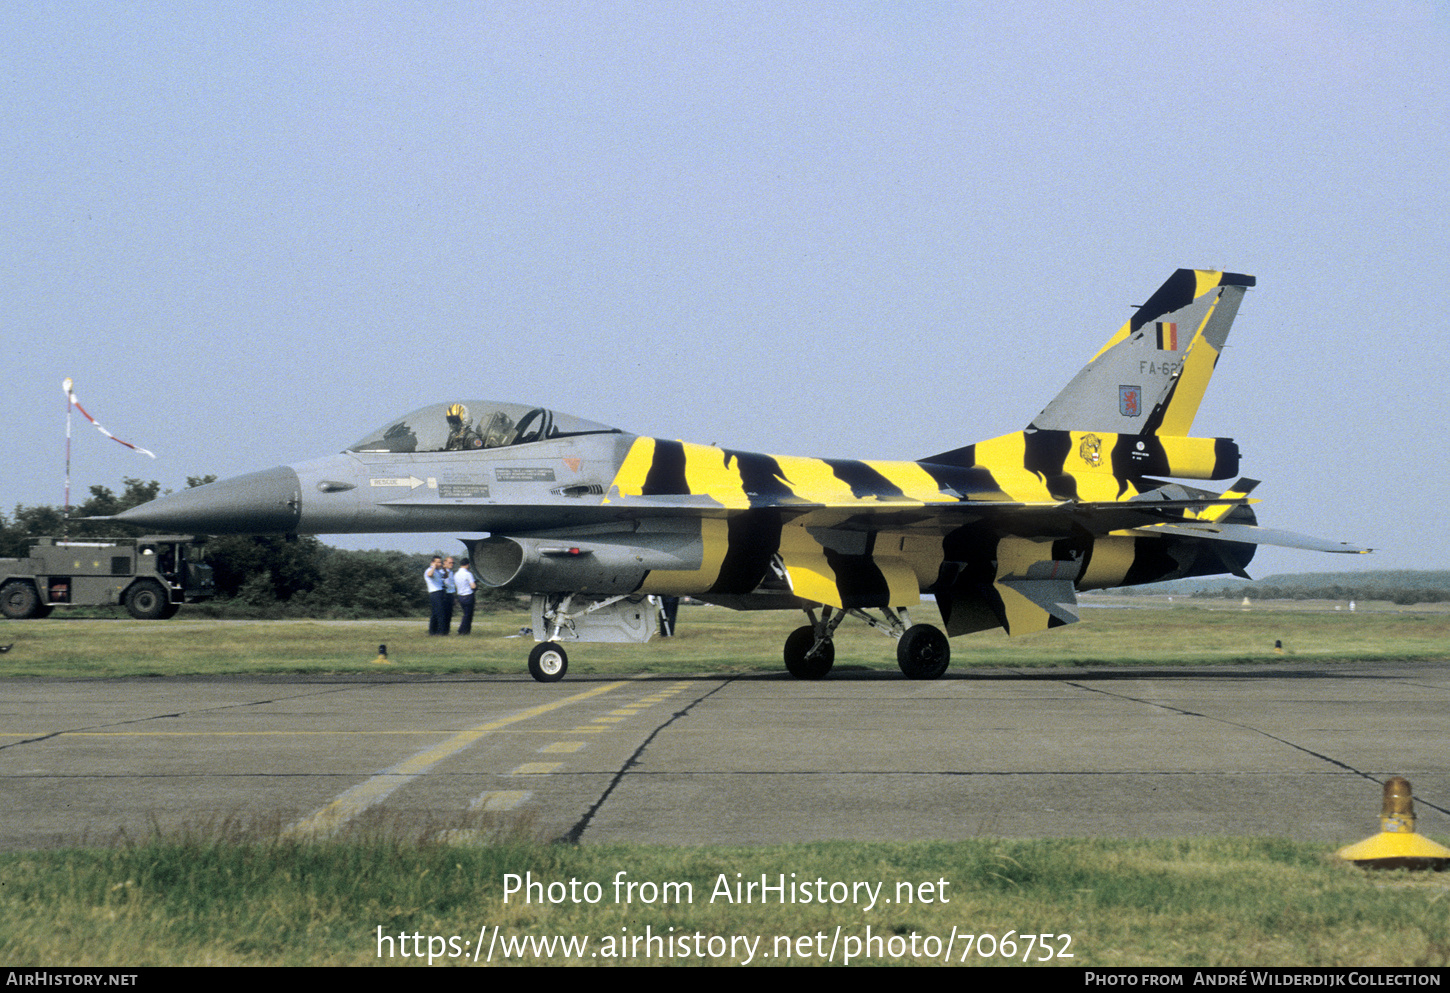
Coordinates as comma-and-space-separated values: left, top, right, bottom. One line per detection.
0, 662, 1450, 848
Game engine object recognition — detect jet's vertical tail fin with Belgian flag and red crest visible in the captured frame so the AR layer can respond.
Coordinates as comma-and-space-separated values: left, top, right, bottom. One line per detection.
1028, 270, 1256, 435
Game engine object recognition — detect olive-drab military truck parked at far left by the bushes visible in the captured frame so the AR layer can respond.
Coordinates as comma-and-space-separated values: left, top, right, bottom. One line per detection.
0, 535, 216, 620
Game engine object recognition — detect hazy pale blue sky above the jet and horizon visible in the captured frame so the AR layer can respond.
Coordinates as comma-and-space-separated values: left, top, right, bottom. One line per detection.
0, 0, 1450, 574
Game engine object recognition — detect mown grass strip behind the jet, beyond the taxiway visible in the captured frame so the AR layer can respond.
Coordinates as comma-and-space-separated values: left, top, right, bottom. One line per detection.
0, 591, 1450, 677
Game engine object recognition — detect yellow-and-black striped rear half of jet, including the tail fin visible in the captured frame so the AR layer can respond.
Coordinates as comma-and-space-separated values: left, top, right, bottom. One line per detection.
588, 270, 1256, 635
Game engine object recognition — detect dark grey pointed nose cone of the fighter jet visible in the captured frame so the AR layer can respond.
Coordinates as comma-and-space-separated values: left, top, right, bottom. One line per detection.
116, 465, 302, 535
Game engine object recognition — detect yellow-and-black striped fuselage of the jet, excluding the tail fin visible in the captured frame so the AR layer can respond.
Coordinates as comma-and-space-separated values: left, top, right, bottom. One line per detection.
605, 431, 1251, 635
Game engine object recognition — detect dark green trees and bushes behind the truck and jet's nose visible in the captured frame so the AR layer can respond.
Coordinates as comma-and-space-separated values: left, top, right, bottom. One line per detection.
0, 475, 518, 618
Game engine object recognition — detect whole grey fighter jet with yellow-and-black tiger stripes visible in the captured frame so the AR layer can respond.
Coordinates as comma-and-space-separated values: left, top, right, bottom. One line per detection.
119, 270, 1364, 681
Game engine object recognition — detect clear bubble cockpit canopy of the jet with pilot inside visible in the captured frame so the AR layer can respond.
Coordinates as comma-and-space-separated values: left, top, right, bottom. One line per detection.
345, 400, 619, 452
